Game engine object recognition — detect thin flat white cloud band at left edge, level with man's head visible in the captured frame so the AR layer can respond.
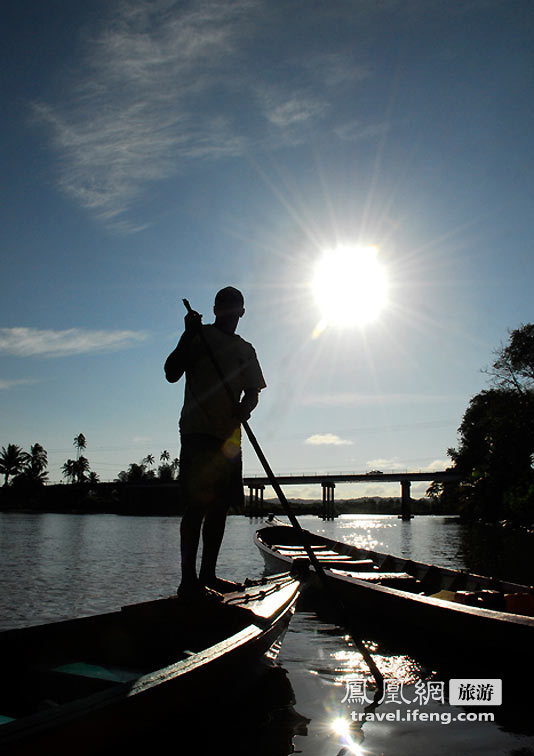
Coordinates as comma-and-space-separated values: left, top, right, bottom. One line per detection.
0, 328, 147, 357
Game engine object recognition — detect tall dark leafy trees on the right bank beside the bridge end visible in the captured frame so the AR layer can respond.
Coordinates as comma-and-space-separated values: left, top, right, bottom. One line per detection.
427, 324, 534, 527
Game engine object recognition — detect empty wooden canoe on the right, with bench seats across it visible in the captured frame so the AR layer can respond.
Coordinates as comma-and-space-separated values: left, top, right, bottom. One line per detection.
255, 524, 534, 666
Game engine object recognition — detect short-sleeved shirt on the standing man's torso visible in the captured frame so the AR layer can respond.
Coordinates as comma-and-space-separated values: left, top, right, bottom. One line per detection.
180, 325, 266, 440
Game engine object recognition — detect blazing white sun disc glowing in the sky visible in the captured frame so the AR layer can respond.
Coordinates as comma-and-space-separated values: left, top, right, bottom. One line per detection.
312, 245, 387, 332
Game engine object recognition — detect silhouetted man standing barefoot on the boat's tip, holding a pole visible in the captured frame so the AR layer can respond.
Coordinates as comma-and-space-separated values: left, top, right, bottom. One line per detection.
165, 286, 266, 598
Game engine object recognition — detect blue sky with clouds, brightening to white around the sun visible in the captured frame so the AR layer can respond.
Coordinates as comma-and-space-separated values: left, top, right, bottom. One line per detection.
0, 0, 534, 496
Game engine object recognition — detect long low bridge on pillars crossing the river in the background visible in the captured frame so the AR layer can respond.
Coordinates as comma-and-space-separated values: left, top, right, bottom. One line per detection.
243, 470, 460, 520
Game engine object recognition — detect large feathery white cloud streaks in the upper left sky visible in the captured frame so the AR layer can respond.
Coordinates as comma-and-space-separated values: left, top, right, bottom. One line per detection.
31, 0, 260, 229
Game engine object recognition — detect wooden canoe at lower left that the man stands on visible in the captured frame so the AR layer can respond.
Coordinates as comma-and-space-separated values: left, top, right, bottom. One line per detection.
0, 573, 300, 754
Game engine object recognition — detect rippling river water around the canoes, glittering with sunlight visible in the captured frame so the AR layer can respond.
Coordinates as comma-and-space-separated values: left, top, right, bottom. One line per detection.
0, 513, 534, 756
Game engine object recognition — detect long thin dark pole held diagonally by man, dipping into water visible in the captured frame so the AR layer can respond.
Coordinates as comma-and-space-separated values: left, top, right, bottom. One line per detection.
182, 299, 384, 702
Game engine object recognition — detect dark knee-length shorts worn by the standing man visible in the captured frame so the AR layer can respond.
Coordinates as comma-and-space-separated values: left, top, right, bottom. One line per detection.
179, 434, 245, 512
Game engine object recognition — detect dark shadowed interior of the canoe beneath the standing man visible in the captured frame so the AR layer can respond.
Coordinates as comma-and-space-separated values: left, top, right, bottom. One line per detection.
0, 599, 262, 724
